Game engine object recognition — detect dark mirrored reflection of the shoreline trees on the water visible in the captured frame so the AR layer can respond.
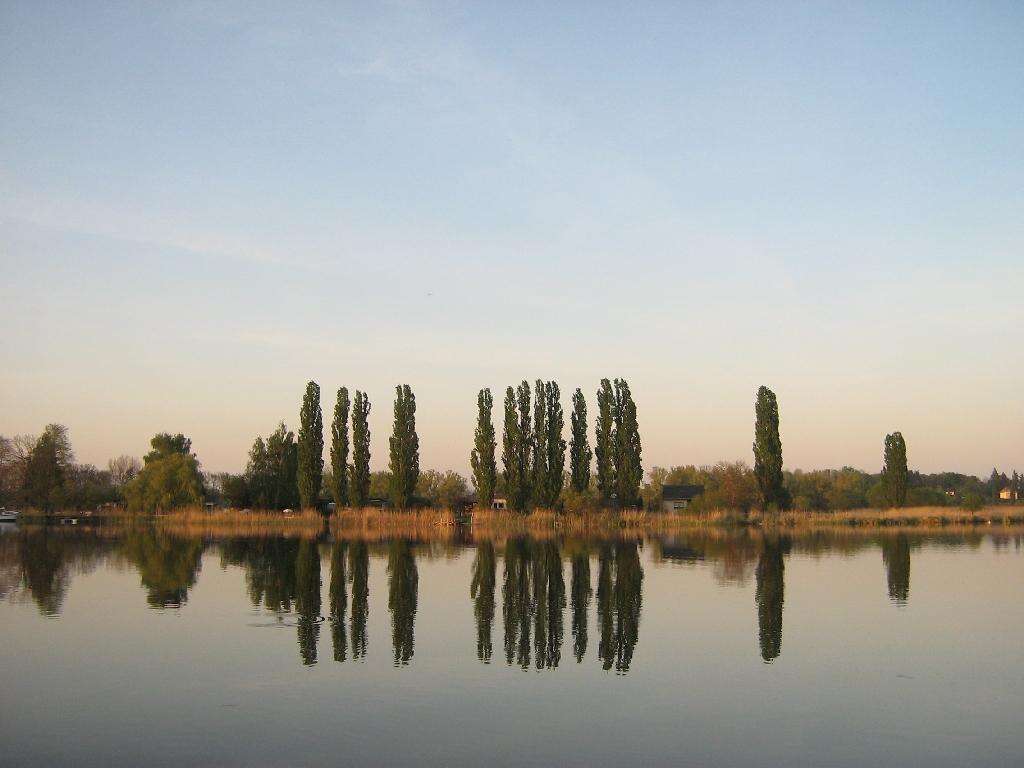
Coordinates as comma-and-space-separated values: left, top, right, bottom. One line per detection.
0, 526, 1021, 674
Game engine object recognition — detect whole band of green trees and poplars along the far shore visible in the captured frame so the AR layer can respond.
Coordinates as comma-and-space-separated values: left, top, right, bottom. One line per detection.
0, 379, 1024, 512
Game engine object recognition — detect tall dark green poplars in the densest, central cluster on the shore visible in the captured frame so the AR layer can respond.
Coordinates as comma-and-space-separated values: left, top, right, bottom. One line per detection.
470, 379, 643, 512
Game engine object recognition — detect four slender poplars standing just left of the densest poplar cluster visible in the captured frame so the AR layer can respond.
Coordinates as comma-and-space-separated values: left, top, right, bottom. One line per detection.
297, 381, 420, 509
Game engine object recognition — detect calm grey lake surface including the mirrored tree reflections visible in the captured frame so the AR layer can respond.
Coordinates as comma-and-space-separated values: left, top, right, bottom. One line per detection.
0, 526, 1024, 766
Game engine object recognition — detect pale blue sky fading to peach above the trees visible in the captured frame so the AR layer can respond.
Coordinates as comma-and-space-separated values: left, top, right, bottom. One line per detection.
0, 0, 1024, 475
